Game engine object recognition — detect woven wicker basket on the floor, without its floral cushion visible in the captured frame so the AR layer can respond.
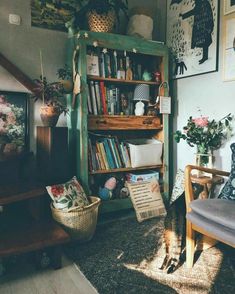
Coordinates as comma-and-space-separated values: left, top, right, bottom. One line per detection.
51, 196, 100, 242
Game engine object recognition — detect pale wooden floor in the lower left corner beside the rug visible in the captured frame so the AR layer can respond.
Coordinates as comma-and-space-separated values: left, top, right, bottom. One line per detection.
0, 257, 98, 294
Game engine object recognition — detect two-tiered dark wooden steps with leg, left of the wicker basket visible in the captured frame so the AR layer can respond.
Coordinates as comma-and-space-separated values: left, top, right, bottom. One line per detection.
0, 182, 70, 269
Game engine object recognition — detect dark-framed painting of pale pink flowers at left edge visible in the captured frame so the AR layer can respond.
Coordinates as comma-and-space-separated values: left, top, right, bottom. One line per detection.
0, 91, 29, 160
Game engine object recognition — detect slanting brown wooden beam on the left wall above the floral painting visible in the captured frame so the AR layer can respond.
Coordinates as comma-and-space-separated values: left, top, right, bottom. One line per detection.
0, 52, 36, 92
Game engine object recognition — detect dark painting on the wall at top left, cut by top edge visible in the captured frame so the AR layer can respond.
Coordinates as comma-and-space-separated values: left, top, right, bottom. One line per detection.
31, 0, 78, 32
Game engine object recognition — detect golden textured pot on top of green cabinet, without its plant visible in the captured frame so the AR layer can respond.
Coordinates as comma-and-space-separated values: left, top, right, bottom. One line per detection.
87, 10, 116, 33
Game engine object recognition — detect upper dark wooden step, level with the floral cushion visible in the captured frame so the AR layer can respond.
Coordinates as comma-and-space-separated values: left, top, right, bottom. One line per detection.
0, 182, 47, 205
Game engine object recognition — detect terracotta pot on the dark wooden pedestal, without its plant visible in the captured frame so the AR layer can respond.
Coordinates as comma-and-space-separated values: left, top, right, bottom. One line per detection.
40, 105, 61, 127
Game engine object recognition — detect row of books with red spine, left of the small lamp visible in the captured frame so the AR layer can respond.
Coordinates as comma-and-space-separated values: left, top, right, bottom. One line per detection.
87, 81, 133, 115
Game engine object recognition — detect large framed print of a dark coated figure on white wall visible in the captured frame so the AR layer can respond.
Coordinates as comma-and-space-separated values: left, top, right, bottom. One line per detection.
167, 0, 219, 79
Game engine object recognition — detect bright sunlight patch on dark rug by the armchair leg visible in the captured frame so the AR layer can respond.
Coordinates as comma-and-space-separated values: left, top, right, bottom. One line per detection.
123, 248, 223, 294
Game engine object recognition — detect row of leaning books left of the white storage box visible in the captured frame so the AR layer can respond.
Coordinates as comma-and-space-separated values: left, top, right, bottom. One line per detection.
88, 137, 131, 172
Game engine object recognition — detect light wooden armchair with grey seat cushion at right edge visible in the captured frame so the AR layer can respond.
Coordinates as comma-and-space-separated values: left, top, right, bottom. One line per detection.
185, 165, 235, 268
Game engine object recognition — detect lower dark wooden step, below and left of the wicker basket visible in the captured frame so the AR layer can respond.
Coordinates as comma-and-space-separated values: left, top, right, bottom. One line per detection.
0, 222, 70, 257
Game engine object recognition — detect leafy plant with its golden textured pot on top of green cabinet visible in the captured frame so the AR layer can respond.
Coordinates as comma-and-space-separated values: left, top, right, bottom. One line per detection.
75, 0, 128, 32
